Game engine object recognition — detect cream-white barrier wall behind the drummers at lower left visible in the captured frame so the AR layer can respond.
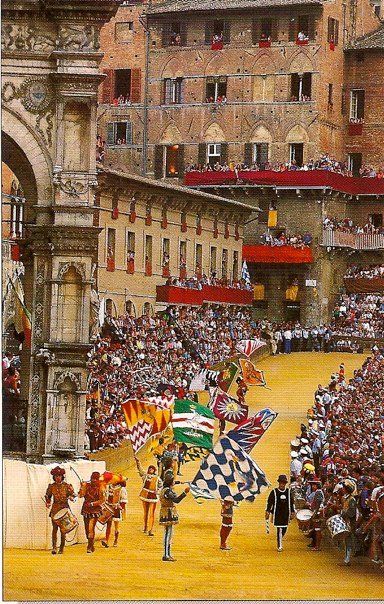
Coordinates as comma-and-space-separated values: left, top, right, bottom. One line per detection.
3, 459, 105, 549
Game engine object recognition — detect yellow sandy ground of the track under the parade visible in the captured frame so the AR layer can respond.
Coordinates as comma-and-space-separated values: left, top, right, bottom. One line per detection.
3, 353, 384, 600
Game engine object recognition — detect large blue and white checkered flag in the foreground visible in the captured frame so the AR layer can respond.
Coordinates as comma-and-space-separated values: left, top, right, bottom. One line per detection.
190, 434, 269, 503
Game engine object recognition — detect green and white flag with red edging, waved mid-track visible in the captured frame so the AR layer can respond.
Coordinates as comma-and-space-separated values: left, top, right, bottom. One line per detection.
171, 399, 215, 449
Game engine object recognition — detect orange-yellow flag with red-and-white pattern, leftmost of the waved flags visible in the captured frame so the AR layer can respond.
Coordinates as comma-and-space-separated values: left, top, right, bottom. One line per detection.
121, 399, 171, 453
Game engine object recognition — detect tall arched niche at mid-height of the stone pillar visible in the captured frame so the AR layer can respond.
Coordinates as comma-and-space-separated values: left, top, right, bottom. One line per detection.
58, 266, 83, 342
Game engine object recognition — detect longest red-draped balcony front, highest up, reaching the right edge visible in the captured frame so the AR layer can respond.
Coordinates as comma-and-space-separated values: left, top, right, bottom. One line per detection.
184, 170, 384, 195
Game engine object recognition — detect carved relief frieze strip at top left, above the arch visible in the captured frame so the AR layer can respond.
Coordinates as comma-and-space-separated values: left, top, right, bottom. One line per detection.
1, 23, 56, 52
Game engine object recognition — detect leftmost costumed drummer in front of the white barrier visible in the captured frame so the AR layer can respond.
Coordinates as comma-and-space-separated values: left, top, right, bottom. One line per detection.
45, 466, 75, 554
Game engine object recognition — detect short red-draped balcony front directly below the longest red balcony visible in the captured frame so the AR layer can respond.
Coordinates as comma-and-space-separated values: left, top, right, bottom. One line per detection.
243, 245, 313, 264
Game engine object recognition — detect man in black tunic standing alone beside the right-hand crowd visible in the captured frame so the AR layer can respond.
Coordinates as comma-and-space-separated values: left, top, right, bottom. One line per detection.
265, 474, 295, 552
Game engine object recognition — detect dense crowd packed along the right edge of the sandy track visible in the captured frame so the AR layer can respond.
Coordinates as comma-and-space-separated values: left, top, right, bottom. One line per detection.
291, 346, 384, 568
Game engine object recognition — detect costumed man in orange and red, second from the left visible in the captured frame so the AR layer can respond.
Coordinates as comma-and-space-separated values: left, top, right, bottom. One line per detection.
79, 472, 105, 554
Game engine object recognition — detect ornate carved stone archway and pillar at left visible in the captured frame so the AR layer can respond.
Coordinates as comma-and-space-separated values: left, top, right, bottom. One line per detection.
2, 0, 118, 461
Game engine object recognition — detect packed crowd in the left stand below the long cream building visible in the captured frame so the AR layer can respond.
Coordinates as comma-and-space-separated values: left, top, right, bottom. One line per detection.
86, 306, 260, 451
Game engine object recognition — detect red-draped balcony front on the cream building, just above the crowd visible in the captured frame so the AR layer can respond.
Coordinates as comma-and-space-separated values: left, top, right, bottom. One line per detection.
156, 285, 253, 306
